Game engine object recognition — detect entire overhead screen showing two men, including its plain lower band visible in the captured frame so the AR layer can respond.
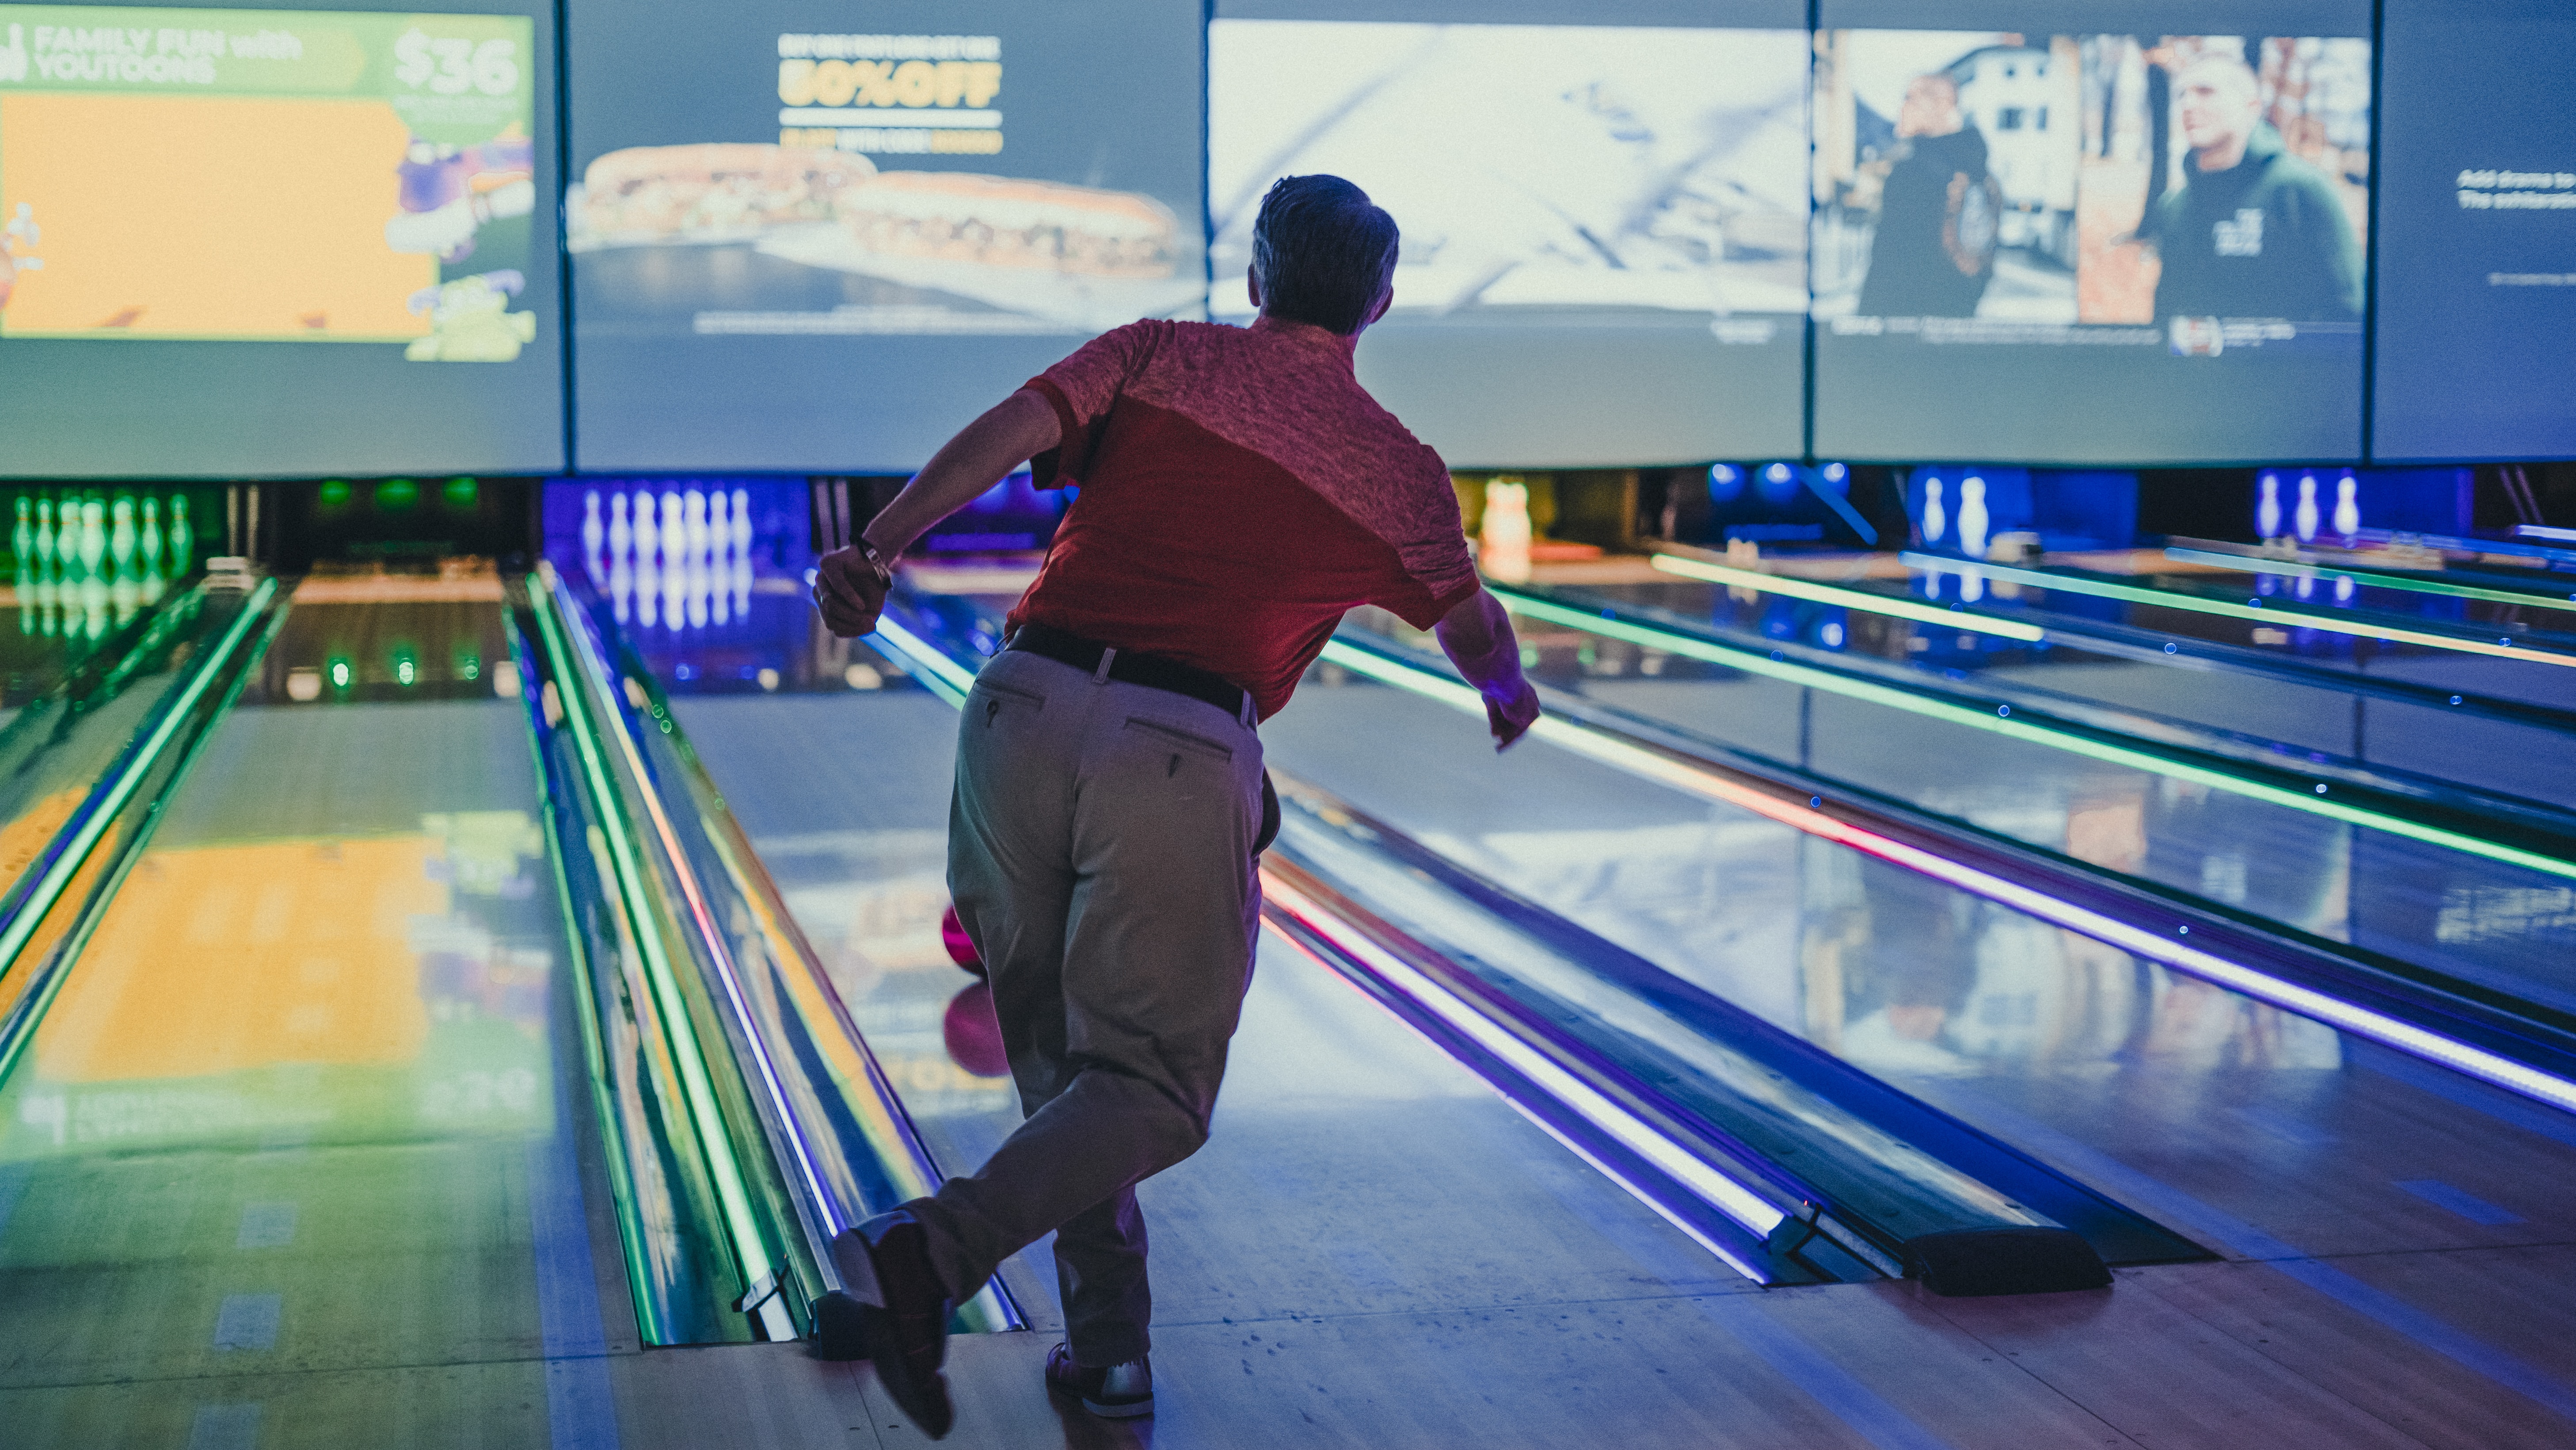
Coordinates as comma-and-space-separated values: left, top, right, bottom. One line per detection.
1814, 0, 2373, 464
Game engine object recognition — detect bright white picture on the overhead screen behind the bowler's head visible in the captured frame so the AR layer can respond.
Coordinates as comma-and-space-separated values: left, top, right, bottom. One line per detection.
1208, 21, 1806, 329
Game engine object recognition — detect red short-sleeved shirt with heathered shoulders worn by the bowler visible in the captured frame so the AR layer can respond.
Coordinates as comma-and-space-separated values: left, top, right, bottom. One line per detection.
1010, 319, 1476, 718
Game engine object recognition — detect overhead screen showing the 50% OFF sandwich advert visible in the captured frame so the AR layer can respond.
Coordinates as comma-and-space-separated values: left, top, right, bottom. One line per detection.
564, 0, 1206, 474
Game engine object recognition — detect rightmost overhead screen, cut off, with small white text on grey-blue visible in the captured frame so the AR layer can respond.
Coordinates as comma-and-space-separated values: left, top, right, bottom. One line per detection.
2373, 0, 2576, 458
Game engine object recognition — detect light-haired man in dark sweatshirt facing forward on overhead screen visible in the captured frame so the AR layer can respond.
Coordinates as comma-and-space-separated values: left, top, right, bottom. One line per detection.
2141, 54, 2362, 322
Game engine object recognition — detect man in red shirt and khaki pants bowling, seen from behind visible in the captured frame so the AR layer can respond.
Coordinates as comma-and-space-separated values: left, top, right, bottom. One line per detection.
814, 175, 1538, 1435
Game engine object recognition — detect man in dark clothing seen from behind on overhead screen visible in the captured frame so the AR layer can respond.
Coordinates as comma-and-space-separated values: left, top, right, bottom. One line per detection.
1860, 69, 1996, 317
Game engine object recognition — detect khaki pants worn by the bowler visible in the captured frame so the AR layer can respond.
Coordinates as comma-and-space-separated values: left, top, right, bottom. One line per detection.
909, 649, 1262, 1365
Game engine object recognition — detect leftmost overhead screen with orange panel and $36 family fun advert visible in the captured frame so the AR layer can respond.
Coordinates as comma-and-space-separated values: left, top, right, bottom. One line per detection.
0, 0, 564, 479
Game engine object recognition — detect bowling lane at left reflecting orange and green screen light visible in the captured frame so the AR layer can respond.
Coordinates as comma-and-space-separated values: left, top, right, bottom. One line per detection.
0, 587, 636, 1445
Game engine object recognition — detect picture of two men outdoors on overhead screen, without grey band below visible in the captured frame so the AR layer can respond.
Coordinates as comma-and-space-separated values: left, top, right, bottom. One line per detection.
1814, 31, 2370, 355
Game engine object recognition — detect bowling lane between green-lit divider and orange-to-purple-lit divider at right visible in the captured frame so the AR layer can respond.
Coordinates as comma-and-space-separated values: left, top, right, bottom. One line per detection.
1352, 590, 2576, 1012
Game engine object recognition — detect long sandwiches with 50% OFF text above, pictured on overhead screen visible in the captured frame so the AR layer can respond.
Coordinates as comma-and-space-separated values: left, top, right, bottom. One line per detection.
567, 36, 1203, 335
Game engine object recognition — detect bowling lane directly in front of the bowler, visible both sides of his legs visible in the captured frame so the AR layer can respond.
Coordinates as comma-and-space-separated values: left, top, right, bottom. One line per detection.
659, 675, 1752, 1329
